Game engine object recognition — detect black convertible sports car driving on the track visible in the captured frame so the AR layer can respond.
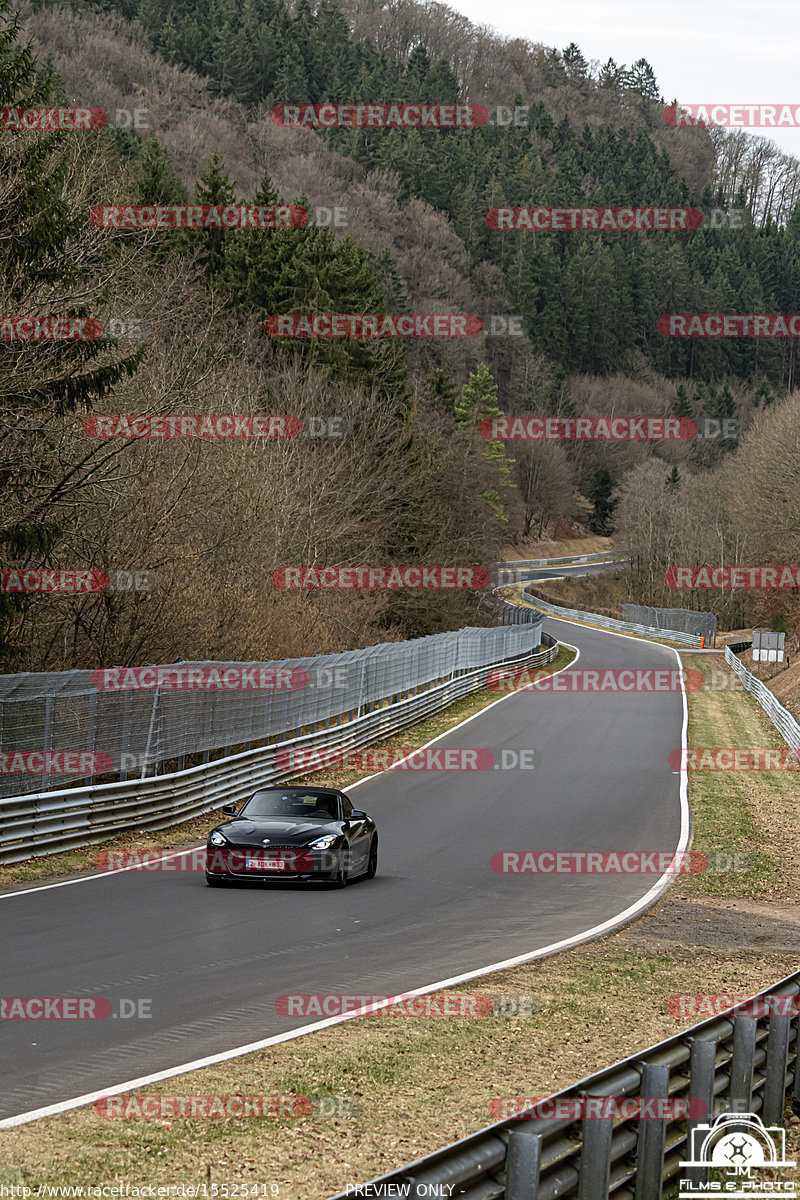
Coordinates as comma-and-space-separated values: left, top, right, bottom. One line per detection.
205, 787, 378, 888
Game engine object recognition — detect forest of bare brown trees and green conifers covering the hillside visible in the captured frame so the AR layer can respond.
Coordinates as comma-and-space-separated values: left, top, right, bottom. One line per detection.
0, 0, 800, 670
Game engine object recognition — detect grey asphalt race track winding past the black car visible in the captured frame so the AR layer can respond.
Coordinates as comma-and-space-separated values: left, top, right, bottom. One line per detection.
0, 619, 686, 1118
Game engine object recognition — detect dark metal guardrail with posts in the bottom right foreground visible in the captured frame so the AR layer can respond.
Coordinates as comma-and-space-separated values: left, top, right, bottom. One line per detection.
331, 972, 800, 1200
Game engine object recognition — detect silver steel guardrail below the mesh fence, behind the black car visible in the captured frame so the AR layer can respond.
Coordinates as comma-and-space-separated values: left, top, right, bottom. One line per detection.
0, 619, 559, 863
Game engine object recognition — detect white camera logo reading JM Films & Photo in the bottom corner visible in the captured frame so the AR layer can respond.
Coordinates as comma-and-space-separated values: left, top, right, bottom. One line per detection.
679, 1112, 796, 1200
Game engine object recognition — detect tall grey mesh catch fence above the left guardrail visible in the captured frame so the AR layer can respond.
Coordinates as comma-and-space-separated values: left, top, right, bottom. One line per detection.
0, 613, 542, 796
